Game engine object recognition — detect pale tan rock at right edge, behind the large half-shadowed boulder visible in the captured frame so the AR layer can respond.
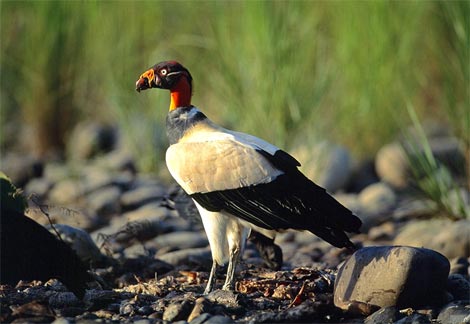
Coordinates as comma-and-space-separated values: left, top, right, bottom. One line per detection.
393, 218, 470, 259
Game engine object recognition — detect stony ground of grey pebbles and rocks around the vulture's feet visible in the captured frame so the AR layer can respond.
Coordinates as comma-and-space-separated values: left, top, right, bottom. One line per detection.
0, 122, 470, 324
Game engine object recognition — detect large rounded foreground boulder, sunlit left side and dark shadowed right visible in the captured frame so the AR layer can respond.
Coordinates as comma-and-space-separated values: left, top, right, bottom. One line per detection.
334, 246, 450, 310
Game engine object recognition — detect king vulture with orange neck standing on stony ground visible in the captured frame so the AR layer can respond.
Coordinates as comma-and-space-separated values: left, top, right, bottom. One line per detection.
136, 61, 362, 294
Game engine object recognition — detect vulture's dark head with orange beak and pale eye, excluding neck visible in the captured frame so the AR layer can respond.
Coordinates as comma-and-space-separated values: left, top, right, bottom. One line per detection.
135, 61, 192, 92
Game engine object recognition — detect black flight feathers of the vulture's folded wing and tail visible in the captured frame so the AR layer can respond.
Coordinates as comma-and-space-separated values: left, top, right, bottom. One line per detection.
191, 151, 362, 247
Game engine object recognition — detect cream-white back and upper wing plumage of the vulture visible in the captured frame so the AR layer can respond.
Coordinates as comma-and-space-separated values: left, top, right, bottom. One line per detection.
166, 124, 283, 194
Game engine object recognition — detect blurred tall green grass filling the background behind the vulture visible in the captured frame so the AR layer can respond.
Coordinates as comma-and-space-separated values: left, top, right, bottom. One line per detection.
0, 1, 470, 170
